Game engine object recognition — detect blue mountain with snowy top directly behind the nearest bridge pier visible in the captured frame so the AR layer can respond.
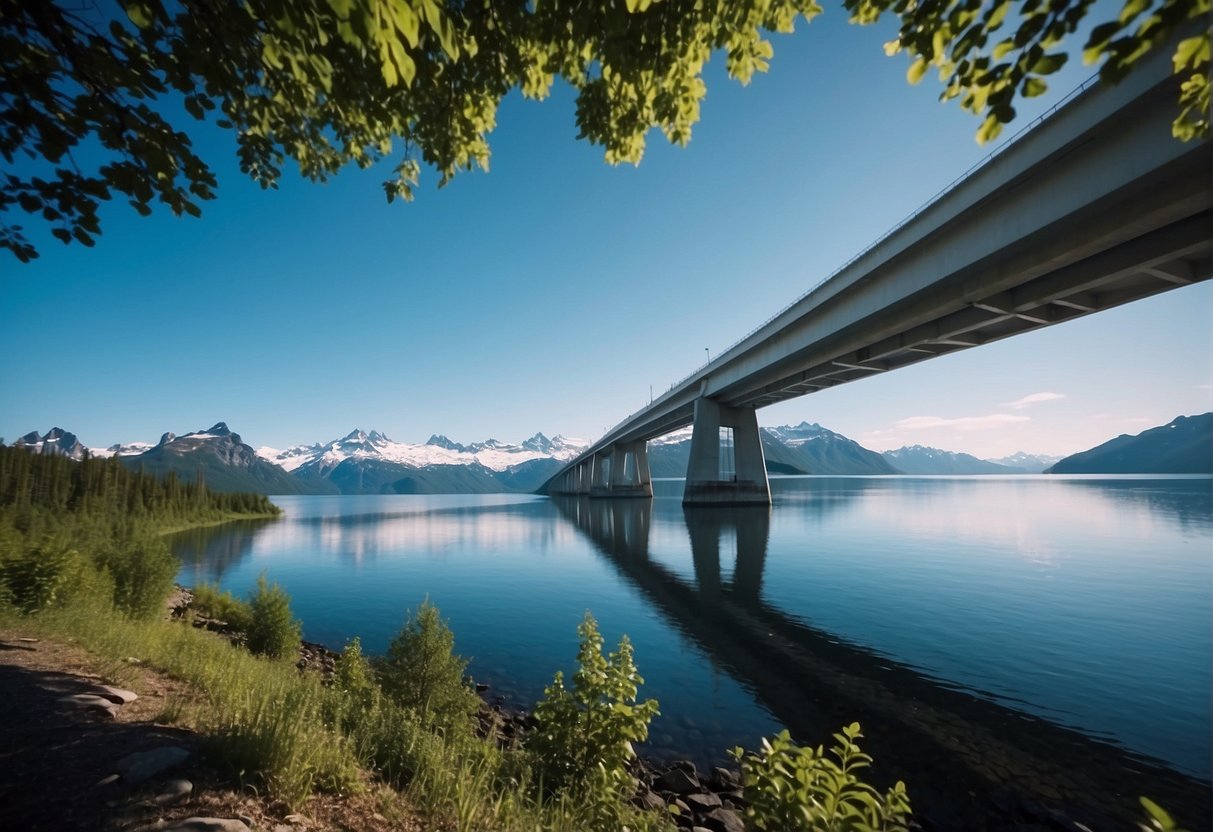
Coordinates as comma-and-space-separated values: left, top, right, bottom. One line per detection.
649, 422, 900, 477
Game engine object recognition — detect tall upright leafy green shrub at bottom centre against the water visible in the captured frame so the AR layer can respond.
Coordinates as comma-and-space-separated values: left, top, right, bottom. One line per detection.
528, 612, 657, 798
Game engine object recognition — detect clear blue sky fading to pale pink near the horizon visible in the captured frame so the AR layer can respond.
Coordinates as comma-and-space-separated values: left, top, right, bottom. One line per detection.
0, 7, 1213, 456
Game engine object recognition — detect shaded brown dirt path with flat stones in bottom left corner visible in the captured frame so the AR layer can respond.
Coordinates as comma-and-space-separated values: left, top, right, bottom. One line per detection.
0, 631, 425, 832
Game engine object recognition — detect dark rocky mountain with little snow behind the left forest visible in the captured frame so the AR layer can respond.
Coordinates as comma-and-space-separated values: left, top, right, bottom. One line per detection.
119, 422, 336, 494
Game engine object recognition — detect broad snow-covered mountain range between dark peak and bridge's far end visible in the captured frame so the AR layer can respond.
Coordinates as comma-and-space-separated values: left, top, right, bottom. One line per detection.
257, 429, 586, 494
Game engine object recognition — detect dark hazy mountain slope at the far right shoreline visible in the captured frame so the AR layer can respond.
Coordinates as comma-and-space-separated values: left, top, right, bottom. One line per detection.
1044, 412, 1213, 474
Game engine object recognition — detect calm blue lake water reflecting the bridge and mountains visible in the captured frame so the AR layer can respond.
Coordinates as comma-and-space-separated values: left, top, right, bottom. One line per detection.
173, 477, 1213, 824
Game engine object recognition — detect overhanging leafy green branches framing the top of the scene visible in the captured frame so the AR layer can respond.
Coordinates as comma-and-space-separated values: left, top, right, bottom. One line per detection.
0, 0, 1209, 262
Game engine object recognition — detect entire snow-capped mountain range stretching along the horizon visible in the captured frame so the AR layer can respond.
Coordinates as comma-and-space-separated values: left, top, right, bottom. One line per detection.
13, 414, 1213, 494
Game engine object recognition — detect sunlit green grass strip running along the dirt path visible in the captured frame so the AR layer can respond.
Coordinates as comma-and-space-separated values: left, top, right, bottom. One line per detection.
0, 603, 671, 832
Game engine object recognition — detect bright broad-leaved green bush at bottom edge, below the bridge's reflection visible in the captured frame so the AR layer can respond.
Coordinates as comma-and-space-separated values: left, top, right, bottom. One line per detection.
733, 723, 910, 832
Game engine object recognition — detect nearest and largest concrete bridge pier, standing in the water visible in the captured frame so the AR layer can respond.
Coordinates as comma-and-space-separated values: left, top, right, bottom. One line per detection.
683, 397, 770, 506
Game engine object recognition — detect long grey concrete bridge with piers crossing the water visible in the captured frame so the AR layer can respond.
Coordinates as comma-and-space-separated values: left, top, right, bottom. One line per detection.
540, 40, 1213, 505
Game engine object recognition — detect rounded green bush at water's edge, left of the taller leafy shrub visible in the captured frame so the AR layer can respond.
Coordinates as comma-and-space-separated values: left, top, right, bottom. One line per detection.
378, 598, 480, 733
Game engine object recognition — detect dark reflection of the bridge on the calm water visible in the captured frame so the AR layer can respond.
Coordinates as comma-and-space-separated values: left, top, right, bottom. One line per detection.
553, 497, 1213, 831
